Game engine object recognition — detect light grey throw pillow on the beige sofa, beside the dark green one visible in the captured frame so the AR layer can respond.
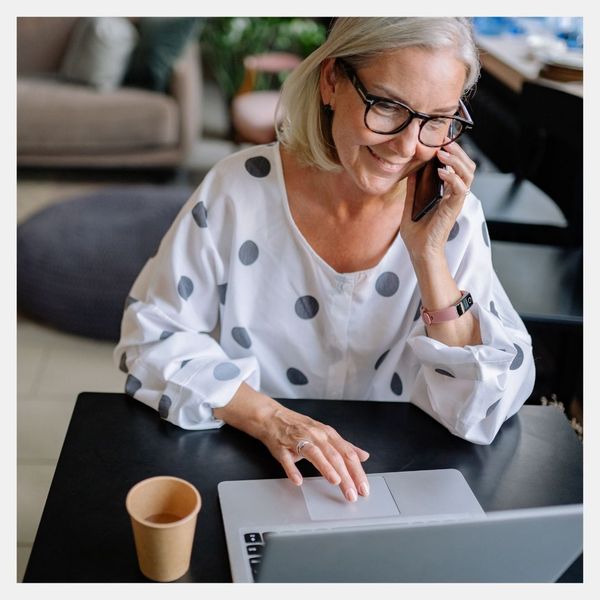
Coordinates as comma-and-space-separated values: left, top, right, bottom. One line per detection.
59, 17, 138, 90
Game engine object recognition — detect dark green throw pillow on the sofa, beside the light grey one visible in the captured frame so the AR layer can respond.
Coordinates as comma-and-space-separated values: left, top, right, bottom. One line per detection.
125, 17, 199, 92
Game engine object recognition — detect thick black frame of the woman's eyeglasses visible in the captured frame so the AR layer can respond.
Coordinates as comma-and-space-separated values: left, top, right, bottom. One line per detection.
336, 58, 474, 148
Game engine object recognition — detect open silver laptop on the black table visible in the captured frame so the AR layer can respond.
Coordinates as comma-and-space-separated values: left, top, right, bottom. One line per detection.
218, 469, 583, 583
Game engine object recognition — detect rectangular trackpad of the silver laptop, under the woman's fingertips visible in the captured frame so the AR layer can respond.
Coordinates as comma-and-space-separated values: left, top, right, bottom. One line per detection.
301, 476, 400, 521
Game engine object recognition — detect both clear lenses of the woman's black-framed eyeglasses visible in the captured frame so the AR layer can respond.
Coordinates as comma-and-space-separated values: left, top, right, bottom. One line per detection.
366, 102, 463, 146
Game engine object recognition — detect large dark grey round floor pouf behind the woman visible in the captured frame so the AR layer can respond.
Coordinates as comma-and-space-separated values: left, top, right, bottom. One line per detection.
17, 185, 192, 341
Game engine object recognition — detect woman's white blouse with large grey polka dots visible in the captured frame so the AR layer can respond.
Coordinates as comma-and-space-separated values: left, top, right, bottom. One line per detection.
114, 143, 535, 444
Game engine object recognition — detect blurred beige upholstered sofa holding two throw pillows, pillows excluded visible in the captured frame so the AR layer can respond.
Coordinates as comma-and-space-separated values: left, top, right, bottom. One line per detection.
17, 17, 202, 168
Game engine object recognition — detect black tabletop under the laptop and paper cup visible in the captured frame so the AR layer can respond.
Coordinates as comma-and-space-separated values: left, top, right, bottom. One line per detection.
24, 393, 583, 582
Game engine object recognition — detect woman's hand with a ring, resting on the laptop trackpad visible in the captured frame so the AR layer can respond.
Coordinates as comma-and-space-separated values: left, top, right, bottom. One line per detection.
214, 383, 369, 502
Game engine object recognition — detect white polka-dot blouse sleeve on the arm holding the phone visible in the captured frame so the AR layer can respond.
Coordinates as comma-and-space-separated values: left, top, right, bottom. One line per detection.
407, 195, 535, 444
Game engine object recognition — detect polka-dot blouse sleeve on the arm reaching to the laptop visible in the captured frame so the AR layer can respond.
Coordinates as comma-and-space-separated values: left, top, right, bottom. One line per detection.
113, 173, 260, 429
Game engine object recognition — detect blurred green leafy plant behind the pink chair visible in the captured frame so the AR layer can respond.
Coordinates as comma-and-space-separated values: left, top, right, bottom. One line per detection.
200, 17, 326, 102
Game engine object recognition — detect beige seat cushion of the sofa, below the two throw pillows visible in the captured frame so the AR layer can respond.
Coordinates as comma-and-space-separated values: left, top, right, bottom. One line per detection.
17, 77, 180, 155
